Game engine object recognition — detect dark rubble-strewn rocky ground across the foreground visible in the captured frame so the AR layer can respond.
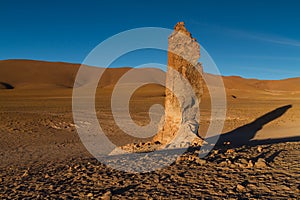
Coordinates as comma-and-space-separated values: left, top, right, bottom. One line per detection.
0, 142, 300, 199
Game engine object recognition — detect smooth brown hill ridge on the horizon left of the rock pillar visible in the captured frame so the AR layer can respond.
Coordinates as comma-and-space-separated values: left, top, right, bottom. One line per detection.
0, 60, 164, 89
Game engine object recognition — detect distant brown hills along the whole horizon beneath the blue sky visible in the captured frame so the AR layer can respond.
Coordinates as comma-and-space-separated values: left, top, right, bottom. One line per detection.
0, 60, 300, 92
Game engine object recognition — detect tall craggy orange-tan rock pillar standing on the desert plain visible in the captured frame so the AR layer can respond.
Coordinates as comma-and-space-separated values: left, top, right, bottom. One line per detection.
154, 22, 203, 147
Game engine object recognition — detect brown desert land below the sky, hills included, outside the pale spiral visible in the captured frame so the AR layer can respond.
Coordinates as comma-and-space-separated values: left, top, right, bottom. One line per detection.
0, 60, 300, 199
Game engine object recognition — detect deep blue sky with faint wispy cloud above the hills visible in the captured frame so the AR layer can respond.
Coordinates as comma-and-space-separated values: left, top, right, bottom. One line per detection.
0, 0, 300, 79
